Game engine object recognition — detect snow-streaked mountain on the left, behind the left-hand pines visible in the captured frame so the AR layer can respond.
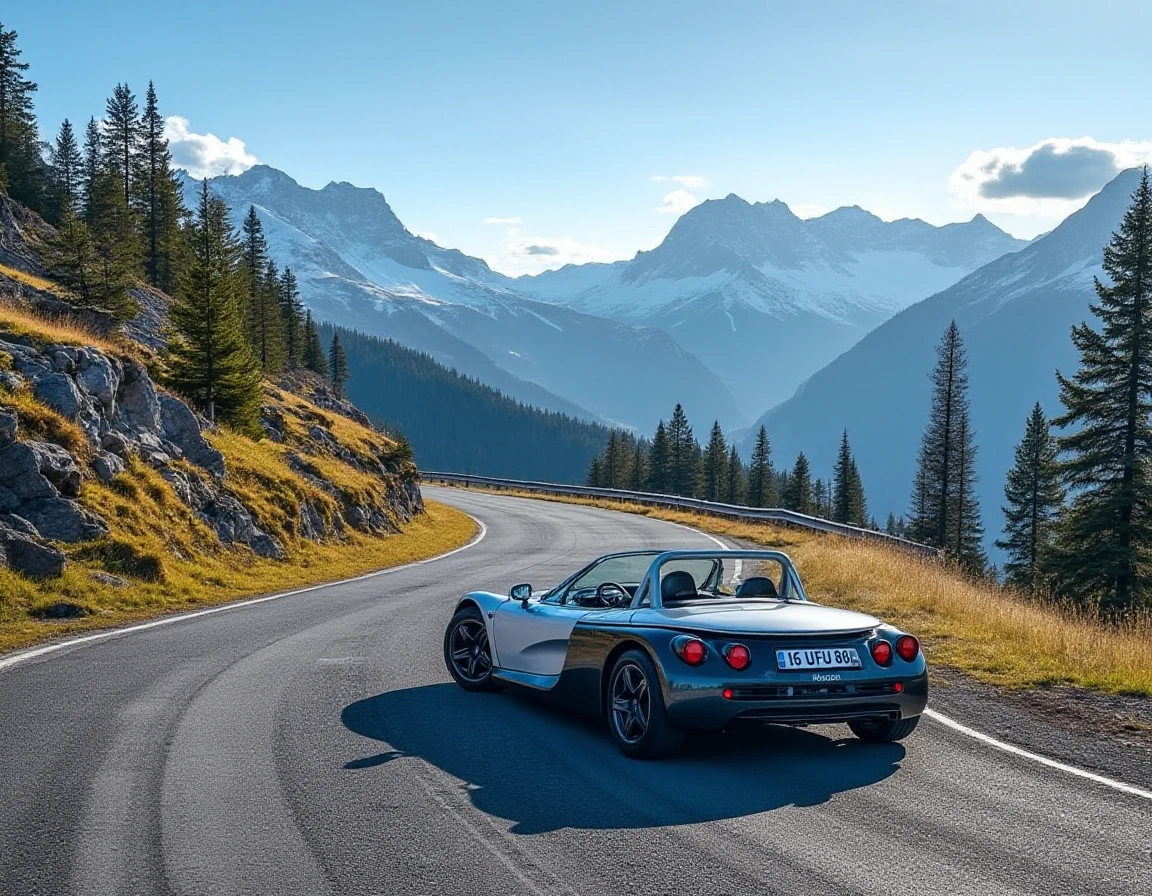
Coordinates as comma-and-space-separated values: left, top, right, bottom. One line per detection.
179, 165, 748, 431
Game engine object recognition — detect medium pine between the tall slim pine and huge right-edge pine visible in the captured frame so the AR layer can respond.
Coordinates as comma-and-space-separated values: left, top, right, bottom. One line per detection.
996, 402, 1064, 593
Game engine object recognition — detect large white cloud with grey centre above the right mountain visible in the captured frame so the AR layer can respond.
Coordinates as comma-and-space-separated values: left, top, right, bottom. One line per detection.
948, 137, 1152, 218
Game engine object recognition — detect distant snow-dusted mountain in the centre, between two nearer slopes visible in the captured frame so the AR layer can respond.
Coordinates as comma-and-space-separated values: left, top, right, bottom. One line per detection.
516, 195, 1026, 417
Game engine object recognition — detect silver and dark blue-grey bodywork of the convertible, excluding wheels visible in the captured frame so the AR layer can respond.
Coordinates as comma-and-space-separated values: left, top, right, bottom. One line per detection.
449, 552, 929, 729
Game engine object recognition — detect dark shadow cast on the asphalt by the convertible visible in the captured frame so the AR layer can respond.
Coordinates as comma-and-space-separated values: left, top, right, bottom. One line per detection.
341, 684, 904, 834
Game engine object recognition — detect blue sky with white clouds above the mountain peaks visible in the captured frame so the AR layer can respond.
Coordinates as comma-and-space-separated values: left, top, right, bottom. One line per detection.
11, 0, 1152, 273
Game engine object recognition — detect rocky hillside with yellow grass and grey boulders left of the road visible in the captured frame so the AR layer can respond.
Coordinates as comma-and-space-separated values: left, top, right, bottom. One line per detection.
0, 297, 475, 651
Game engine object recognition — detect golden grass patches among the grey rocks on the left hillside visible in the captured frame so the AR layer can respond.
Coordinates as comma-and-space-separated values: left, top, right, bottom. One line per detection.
0, 309, 476, 651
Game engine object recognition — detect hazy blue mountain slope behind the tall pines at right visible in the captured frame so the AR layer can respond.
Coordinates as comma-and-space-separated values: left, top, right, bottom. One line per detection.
742, 169, 1139, 540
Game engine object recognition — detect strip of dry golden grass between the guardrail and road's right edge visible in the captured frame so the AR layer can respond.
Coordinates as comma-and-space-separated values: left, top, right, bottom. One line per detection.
451, 486, 1152, 697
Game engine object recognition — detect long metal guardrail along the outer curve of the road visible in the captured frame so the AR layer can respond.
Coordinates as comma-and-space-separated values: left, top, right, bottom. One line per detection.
420, 470, 940, 556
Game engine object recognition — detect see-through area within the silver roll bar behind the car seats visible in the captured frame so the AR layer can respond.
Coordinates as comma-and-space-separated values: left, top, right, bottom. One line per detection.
659, 554, 797, 605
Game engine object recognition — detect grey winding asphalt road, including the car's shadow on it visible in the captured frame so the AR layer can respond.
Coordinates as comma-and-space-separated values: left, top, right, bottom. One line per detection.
0, 488, 1152, 896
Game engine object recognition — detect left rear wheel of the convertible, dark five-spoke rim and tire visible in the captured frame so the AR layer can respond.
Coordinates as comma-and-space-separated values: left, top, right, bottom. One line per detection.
606, 650, 684, 759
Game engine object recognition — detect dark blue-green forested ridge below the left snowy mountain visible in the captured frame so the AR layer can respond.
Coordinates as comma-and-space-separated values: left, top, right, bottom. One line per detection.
320, 325, 608, 483
